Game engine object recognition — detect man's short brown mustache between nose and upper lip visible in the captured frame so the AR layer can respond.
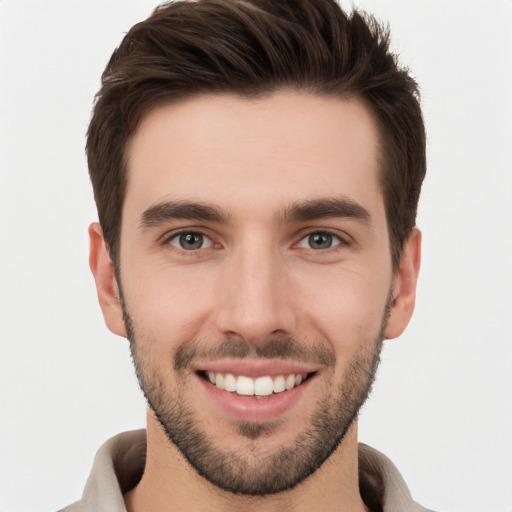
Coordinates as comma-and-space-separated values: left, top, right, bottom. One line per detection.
173, 336, 336, 370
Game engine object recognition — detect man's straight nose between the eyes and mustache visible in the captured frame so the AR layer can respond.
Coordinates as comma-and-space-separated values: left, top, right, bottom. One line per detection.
216, 242, 297, 346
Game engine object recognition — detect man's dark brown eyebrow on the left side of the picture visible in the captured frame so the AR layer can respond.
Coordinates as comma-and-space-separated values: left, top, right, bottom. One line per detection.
140, 201, 229, 228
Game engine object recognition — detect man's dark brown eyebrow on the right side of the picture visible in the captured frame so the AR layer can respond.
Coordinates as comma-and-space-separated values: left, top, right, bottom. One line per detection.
278, 197, 371, 224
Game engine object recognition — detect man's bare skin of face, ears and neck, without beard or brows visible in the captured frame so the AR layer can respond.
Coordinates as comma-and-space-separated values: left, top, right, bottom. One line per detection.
89, 91, 421, 511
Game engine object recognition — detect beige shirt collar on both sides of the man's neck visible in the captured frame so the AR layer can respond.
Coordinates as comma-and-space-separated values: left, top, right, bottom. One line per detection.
60, 430, 432, 512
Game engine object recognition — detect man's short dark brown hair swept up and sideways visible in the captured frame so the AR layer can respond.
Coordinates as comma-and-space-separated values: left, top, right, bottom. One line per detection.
87, 0, 426, 269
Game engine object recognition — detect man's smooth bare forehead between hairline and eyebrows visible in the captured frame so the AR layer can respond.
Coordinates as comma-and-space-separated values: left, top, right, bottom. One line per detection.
123, 92, 382, 221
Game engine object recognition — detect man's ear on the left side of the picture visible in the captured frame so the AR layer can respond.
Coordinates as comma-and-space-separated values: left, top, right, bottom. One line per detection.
89, 222, 127, 338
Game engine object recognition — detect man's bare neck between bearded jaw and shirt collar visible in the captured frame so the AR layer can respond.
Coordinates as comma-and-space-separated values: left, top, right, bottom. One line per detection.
125, 412, 367, 512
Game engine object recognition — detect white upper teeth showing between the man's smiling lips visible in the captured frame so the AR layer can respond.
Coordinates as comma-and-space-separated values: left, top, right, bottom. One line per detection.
197, 371, 316, 398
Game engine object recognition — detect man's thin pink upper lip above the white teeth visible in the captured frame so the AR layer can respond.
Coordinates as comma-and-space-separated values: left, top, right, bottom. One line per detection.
192, 359, 318, 378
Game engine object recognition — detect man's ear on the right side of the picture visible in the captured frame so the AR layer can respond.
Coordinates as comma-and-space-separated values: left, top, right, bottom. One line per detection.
385, 228, 421, 339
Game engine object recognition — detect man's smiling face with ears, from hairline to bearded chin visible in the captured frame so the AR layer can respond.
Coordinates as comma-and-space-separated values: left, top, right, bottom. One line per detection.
91, 92, 417, 494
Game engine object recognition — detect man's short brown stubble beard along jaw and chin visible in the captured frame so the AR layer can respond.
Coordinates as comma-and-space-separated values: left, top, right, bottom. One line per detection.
122, 301, 389, 496
